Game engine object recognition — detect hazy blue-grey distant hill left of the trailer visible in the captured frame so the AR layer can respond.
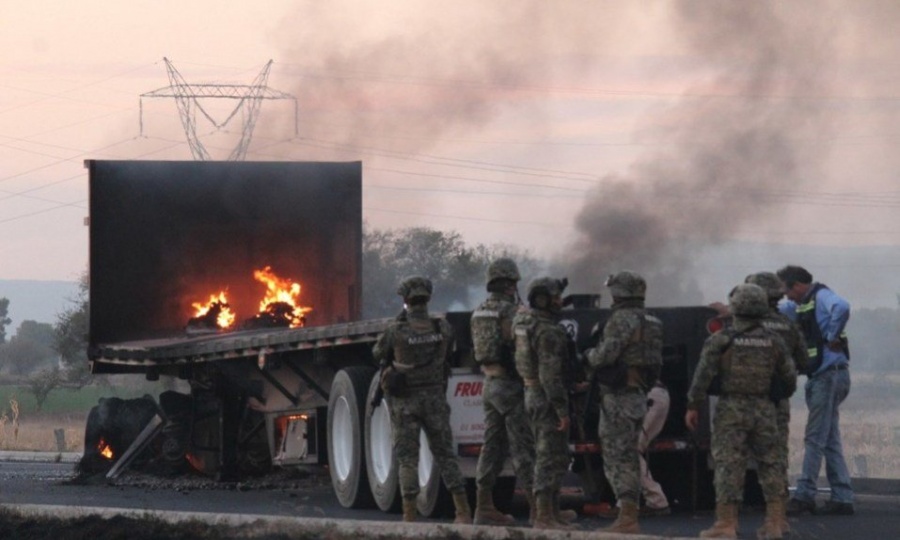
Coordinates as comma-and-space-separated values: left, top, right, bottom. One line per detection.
0, 280, 78, 337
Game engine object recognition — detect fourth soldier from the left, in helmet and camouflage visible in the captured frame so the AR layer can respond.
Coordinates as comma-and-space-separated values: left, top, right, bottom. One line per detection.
585, 270, 663, 534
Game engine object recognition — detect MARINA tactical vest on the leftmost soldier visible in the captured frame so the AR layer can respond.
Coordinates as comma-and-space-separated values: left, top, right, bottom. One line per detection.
393, 318, 450, 389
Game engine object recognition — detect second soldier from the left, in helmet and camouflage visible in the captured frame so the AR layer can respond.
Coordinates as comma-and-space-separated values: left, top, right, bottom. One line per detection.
471, 258, 534, 525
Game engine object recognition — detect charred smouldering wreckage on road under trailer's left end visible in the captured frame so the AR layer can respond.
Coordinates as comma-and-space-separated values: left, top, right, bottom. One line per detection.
75, 374, 272, 480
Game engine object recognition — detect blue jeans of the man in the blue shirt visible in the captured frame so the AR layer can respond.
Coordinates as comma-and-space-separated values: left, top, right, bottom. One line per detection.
794, 369, 853, 503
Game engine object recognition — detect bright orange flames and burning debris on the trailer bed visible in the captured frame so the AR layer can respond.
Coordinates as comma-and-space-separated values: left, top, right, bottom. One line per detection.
186, 266, 312, 334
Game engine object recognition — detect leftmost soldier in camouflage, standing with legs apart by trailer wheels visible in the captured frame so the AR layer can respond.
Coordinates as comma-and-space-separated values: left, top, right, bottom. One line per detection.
372, 276, 472, 523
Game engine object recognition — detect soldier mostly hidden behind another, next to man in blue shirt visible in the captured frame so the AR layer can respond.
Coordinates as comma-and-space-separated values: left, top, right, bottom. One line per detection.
744, 272, 808, 532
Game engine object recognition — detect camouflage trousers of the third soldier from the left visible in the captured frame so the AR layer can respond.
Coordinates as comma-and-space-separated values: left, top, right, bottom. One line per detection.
525, 386, 570, 493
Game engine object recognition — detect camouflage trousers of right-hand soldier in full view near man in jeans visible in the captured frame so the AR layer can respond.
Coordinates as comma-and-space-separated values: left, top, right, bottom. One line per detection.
712, 395, 786, 504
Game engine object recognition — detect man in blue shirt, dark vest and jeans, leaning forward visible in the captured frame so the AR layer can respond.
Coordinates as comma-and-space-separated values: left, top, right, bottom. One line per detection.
778, 266, 853, 515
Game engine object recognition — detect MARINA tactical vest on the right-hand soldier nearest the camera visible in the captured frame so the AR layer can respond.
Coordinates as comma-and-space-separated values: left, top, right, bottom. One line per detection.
719, 326, 782, 396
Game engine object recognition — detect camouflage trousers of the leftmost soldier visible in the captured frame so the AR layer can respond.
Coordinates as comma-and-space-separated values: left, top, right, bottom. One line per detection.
388, 387, 466, 498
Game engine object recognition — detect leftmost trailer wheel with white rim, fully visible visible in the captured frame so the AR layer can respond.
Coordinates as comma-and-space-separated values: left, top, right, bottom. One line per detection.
327, 366, 375, 508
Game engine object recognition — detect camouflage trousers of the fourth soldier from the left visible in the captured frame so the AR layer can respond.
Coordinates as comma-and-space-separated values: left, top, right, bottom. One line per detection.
597, 390, 647, 504
